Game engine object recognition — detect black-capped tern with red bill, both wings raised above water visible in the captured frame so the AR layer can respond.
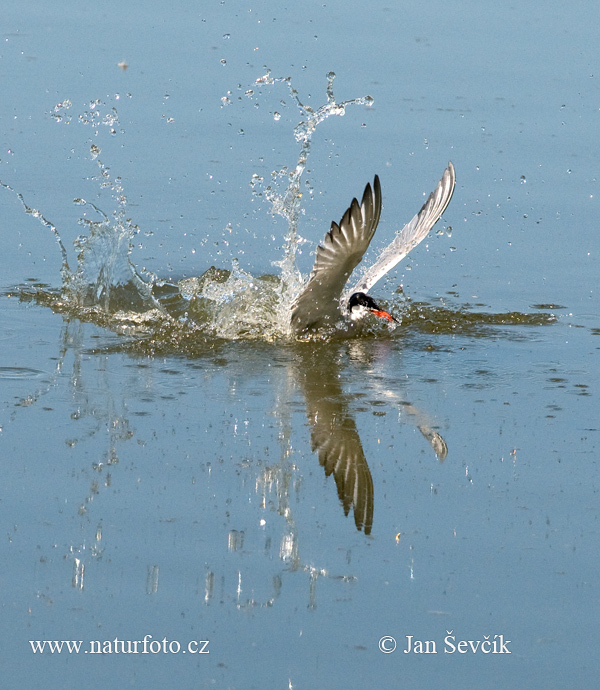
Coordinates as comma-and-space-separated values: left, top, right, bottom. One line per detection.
291, 162, 456, 336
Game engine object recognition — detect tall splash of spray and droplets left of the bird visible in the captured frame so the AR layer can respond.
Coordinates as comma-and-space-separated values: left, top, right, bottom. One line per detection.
3, 72, 373, 340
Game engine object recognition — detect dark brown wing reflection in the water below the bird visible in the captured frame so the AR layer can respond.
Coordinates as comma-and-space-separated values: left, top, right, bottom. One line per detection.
296, 343, 374, 534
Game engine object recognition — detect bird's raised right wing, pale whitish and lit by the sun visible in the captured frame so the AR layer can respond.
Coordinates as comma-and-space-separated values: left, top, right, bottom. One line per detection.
345, 163, 456, 297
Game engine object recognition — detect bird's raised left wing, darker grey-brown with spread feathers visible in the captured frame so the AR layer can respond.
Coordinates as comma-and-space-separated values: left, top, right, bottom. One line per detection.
292, 176, 381, 333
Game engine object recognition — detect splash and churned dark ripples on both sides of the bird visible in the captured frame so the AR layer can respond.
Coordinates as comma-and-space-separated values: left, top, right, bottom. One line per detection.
0, 80, 555, 352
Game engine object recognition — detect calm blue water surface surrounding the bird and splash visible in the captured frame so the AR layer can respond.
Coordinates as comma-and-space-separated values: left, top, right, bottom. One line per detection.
0, 1, 600, 688
